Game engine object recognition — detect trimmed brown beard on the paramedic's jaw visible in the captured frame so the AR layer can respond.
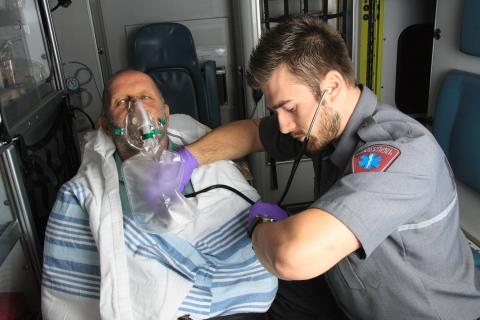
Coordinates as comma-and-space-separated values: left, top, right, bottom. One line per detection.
292, 105, 341, 153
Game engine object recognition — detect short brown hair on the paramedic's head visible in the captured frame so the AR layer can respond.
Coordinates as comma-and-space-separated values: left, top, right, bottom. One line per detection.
247, 15, 355, 96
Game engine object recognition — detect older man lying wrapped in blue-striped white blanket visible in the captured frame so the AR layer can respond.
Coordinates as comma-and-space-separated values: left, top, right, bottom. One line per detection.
42, 70, 277, 319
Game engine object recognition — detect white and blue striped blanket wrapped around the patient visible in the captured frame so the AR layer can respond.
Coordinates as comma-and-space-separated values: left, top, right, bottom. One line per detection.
42, 115, 277, 319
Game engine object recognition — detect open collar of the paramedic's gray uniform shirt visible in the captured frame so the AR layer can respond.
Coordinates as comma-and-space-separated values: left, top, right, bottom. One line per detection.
330, 86, 377, 169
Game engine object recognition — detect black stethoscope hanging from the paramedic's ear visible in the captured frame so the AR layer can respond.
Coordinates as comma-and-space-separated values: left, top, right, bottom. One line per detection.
185, 88, 332, 206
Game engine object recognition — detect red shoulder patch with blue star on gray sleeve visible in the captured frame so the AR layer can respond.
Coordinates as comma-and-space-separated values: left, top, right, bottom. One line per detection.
352, 144, 400, 173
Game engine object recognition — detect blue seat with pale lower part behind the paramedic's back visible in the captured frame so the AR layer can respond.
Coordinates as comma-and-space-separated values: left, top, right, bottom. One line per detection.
432, 70, 480, 255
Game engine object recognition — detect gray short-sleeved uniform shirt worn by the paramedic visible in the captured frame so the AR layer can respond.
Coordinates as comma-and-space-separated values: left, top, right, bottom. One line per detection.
260, 88, 480, 320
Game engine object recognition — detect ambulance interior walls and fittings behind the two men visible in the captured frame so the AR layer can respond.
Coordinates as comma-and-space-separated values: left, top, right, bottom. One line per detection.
0, 0, 480, 319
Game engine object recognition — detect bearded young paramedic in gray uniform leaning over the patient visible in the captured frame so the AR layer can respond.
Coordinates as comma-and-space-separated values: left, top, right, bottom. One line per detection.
179, 16, 480, 320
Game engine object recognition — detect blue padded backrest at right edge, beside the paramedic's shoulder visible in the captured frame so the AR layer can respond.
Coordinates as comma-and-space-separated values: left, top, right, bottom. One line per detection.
433, 70, 480, 192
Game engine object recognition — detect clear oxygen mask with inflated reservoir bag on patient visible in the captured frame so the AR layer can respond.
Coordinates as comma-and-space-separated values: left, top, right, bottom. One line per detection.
115, 99, 195, 233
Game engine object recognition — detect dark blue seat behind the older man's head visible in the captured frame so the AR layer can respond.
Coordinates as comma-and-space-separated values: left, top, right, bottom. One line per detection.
132, 22, 220, 128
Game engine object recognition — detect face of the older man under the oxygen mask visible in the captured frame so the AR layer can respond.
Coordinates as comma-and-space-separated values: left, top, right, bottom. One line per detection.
102, 71, 169, 160
